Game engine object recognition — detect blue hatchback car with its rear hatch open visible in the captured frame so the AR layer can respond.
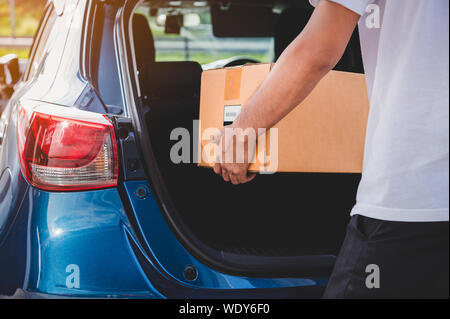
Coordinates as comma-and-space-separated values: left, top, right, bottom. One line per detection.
0, 0, 363, 298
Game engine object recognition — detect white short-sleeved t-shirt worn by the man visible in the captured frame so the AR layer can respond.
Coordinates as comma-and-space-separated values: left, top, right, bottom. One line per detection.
310, 0, 449, 222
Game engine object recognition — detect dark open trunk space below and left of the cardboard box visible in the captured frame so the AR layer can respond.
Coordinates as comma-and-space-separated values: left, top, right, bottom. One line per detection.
135, 62, 360, 276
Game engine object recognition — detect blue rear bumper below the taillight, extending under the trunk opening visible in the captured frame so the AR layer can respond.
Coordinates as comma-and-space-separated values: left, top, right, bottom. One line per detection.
0, 182, 326, 298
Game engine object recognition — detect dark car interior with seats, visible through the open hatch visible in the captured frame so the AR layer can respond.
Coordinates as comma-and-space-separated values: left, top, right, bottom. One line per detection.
132, 1, 364, 276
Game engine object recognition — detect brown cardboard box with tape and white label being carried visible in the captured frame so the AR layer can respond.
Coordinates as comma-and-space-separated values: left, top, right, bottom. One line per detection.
199, 64, 369, 173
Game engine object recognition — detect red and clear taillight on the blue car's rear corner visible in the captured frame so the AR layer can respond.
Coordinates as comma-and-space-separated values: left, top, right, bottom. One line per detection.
17, 101, 118, 191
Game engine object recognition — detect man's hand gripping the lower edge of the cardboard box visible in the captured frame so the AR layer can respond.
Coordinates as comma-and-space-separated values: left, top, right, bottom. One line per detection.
213, 125, 256, 185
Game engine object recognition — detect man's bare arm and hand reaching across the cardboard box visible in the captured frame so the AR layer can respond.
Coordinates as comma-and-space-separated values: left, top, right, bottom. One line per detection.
214, 0, 360, 184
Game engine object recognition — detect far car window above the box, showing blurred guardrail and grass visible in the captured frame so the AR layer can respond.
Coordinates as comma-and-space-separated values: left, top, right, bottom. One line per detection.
135, 5, 274, 65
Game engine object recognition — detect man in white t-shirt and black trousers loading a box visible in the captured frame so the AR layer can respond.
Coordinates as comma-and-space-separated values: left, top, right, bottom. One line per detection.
214, 0, 449, 298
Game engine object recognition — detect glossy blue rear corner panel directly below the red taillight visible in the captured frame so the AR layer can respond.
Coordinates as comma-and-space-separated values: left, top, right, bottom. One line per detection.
20, 188, 161, 298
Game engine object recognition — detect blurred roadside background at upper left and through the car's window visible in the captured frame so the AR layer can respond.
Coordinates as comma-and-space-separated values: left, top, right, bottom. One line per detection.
0, 0, 273, 65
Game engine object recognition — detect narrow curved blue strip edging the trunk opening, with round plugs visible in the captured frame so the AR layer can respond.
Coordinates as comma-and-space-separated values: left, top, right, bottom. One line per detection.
125, 181, 326, 289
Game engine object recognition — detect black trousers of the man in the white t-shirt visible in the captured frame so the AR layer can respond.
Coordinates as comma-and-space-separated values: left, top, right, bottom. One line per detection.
324, 215, 449, 298
